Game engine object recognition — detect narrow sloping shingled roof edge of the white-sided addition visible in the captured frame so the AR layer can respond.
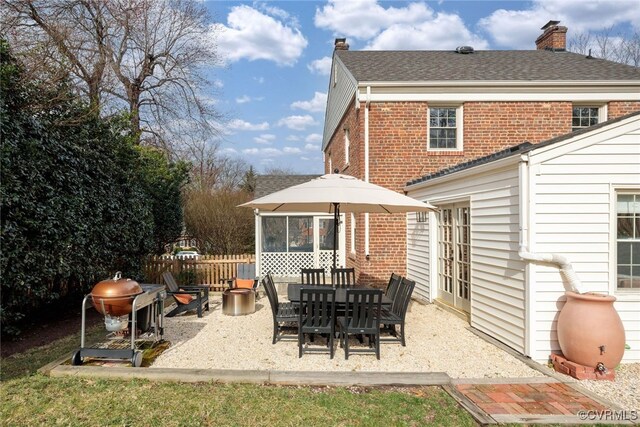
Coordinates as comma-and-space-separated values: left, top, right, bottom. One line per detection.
406, 111, 640, 187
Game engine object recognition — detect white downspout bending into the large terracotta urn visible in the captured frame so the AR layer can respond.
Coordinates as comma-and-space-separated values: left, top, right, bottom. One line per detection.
518, 153, 585, 293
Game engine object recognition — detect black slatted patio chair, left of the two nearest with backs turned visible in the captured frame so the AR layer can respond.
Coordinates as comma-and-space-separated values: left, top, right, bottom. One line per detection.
298, 287, 336, 359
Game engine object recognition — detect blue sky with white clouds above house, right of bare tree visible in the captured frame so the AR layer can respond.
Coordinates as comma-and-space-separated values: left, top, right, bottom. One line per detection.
205, 0, 640, 174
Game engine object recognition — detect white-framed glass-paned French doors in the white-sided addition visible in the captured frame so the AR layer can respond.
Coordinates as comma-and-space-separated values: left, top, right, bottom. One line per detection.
438, 204, 471, 313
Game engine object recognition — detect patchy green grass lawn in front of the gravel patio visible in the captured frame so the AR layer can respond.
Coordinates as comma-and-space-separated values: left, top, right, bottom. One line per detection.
0, 327, 475, 426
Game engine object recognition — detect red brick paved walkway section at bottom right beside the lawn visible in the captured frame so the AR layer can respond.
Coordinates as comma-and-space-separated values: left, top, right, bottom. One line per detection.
456, 383, 607, 416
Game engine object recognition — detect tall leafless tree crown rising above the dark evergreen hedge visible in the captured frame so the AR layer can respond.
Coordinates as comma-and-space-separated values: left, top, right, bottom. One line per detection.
1, 0, 221, 148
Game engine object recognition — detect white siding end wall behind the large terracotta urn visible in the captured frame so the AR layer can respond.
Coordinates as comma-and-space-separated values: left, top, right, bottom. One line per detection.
531, 119, 640, 361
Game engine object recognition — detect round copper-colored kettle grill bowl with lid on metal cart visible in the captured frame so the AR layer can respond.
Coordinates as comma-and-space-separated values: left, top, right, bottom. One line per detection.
91, 271, 142, 317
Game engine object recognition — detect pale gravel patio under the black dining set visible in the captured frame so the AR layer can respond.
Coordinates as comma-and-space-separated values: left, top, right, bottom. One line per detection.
152, 296, 544, 378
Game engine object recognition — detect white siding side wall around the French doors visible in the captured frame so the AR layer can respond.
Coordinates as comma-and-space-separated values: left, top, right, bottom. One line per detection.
407, 163, 525, 353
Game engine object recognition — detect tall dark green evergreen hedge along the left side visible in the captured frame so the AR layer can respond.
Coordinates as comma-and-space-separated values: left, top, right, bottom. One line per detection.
0, 40, 187, 336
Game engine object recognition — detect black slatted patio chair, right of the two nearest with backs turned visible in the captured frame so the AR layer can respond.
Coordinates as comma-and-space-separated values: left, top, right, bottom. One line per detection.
338, 288, 382, 360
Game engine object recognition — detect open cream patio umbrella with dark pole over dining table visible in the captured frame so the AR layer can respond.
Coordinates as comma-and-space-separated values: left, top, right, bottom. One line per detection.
240, 174, 436, 268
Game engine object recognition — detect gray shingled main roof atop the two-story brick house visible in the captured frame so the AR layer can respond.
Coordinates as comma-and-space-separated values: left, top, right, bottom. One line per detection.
336, 50, 640, 82
